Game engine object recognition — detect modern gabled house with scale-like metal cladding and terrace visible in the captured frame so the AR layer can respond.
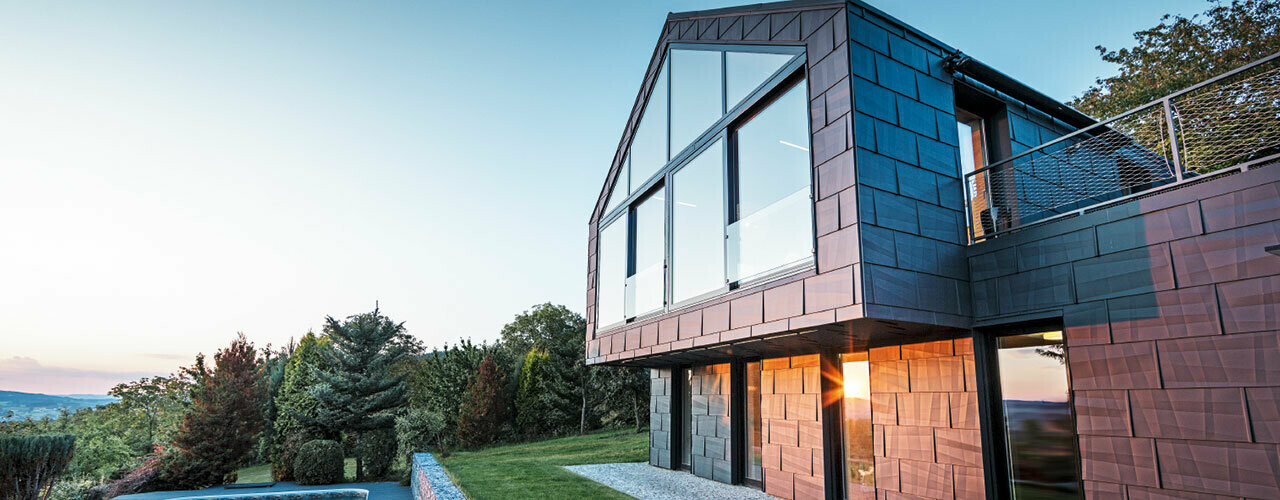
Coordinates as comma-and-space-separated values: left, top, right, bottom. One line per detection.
586, 0, 1280, 500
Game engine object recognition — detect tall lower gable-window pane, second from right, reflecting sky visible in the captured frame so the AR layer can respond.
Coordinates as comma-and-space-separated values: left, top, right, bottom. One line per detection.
671, 141, 726, 303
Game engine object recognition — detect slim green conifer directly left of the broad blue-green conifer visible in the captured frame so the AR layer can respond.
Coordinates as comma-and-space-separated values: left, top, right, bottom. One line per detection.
271, 331, 337, 481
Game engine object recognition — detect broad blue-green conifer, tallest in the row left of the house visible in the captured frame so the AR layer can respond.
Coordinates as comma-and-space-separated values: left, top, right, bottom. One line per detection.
308, 307, 410, 481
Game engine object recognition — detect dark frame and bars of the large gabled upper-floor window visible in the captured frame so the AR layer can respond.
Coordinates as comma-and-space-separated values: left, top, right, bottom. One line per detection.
593, 42, 818, 338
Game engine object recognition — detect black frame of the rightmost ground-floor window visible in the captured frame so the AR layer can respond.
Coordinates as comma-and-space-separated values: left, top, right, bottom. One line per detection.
973, 323, 1087, 499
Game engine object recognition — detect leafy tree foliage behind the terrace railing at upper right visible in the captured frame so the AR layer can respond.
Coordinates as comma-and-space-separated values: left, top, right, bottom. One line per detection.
1071, 0, 1280, 119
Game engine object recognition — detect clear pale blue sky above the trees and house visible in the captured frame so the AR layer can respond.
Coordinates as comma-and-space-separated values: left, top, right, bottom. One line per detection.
0, 0, 1207, 394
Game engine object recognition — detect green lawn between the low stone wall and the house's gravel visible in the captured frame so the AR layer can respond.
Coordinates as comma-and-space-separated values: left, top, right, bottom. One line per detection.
440, 430, 649, 500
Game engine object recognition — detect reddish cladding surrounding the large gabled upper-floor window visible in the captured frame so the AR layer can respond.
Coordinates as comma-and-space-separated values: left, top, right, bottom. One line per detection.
586, 3, 861, 364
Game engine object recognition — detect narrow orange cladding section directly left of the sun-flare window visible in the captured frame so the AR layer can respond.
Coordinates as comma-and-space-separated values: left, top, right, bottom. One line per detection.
760, 354, 824, 500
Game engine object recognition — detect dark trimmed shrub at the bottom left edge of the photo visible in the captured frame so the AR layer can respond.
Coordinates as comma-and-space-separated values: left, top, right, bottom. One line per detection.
0, 434, 76, 500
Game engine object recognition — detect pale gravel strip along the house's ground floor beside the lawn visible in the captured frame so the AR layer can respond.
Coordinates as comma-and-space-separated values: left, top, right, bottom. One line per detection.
564, 462, 777, 500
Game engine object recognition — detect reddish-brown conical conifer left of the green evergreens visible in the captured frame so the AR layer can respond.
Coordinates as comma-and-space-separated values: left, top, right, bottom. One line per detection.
161, 334, 266, 488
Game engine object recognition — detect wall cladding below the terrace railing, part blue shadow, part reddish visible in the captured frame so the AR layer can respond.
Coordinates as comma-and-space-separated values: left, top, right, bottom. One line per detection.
969, 165, 1280, 499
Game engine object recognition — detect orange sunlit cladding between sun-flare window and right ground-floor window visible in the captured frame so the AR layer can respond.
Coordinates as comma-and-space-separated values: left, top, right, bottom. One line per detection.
870, 339, 986, 500
